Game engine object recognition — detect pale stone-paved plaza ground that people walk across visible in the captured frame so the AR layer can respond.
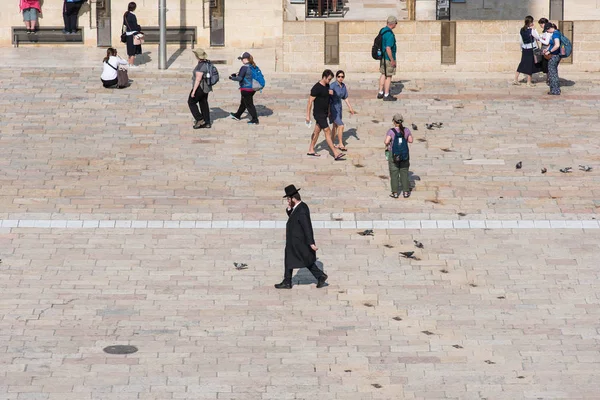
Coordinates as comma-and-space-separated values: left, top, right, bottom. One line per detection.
0, 48, 600, 400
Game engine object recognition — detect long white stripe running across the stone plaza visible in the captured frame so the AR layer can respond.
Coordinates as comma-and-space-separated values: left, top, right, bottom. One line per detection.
0, 219, 600, 230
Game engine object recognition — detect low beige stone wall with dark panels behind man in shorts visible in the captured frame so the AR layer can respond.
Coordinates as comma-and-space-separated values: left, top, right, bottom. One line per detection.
283, 21, 600, 72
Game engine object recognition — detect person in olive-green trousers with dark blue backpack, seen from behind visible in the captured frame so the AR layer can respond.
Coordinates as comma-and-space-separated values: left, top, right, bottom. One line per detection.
384, 114, 413, 199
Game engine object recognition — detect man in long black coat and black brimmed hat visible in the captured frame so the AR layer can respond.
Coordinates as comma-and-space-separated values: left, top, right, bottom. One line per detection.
275, 185, 327, 289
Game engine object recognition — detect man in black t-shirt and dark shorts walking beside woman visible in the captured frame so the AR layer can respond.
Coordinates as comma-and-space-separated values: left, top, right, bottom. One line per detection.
306, 69, 344, 161
